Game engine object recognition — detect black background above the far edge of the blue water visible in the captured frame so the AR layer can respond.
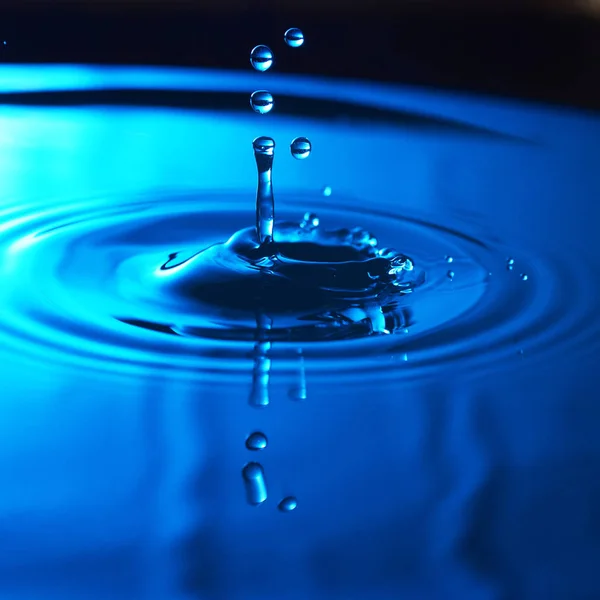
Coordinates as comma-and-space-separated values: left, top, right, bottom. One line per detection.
0, 0, 600, 109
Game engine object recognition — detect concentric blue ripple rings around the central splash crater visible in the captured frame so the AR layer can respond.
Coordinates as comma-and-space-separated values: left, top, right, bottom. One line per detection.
0, 193, 598, 378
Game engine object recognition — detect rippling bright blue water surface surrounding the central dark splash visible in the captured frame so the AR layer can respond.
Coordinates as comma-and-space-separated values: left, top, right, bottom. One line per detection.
0, 66, 600, 600
